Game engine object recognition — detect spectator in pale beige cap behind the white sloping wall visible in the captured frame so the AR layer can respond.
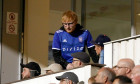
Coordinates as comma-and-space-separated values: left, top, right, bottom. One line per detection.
44, 63, 63, 74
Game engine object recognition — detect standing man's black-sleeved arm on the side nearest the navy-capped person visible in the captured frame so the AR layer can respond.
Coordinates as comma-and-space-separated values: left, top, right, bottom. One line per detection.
88, 46, 99, 63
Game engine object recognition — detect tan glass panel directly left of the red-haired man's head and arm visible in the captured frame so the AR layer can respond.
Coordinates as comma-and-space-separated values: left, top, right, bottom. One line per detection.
48, 0, 71, 65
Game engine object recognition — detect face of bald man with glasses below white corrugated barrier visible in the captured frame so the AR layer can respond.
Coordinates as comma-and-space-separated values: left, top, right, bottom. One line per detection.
115, 61, 127, 76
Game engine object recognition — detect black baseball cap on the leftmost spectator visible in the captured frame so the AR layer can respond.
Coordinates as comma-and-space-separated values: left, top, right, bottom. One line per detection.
20, 62, 41, 76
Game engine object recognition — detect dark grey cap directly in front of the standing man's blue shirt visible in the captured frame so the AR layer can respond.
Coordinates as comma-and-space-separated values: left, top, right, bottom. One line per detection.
71, 52, 90, 63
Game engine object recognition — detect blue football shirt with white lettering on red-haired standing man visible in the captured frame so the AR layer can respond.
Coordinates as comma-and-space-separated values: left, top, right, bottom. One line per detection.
52, 30, 94, 63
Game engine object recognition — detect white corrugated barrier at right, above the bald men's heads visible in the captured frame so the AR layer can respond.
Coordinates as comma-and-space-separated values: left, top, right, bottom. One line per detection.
104, 35, 140, 67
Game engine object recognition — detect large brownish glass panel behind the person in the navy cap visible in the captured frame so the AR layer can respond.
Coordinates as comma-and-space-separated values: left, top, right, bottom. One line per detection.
76, 0, 131, 40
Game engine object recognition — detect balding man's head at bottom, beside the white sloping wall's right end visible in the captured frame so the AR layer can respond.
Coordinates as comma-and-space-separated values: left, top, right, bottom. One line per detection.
95, 67, 116, 84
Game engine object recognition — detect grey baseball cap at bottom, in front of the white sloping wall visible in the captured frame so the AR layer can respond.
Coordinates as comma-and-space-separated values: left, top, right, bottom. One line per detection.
56, 72, 79, 83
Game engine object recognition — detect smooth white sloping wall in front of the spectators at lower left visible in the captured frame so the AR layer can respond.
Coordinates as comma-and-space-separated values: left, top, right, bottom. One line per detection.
10, 64, 104, 84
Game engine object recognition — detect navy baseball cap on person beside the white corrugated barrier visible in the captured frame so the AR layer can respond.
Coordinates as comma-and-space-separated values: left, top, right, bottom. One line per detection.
93, 34, 111, 47
